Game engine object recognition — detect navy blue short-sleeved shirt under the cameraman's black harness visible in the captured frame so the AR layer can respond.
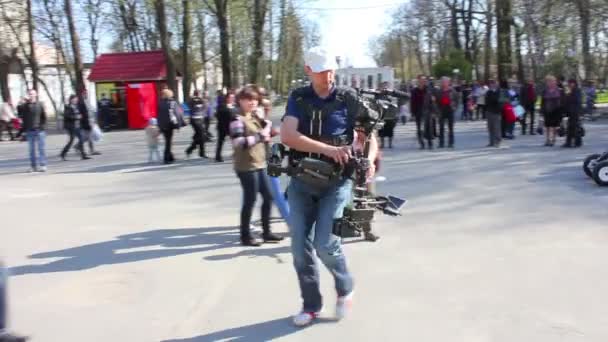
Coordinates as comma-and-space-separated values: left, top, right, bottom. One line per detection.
285, 85, 353, 137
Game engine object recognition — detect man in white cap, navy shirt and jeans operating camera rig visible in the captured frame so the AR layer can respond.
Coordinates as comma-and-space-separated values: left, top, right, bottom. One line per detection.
281, 47, 378, 326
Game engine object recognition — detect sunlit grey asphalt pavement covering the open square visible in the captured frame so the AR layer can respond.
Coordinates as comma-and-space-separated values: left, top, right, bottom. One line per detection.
0, 117, 608, 342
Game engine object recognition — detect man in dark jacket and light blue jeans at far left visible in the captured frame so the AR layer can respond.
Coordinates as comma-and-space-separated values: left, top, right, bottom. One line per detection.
19, 89, 46, 172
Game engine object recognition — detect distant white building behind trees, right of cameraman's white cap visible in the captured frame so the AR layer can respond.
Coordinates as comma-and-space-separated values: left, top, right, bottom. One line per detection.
336, 67, 395, 89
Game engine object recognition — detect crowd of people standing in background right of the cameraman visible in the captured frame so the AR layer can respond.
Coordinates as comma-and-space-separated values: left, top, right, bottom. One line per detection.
402, 75, 597, 149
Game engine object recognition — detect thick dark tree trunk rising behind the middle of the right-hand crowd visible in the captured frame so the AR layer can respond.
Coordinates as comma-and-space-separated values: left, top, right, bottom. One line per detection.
496, 0, 513, 80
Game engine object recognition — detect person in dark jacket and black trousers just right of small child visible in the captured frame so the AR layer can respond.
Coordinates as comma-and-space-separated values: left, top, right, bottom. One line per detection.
157, 89, 184, 164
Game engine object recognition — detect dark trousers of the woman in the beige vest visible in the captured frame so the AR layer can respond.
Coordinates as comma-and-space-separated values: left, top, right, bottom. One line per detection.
237, 169, 272, 240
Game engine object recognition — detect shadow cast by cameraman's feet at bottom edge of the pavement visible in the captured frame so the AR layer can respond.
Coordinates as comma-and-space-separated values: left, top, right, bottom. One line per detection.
162, 317, 336, 342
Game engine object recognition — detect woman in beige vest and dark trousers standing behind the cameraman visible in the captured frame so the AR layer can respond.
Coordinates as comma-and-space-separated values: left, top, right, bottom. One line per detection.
230, 86, 283, 246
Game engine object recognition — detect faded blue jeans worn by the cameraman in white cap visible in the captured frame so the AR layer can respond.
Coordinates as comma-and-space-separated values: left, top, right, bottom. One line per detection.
287, 179, 353, 312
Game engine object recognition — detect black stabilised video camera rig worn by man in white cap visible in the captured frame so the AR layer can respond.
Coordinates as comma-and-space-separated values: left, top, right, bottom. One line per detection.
268, 90, 407, 241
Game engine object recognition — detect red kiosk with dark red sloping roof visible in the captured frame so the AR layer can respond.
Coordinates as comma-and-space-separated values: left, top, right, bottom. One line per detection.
89, 50, 178, 129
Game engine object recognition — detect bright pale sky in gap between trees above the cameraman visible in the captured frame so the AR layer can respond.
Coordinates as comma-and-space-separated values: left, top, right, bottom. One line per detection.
301, 0, 406, 67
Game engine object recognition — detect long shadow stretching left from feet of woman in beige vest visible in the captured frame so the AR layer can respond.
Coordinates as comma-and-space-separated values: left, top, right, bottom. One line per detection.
9, 227, 289, 276
